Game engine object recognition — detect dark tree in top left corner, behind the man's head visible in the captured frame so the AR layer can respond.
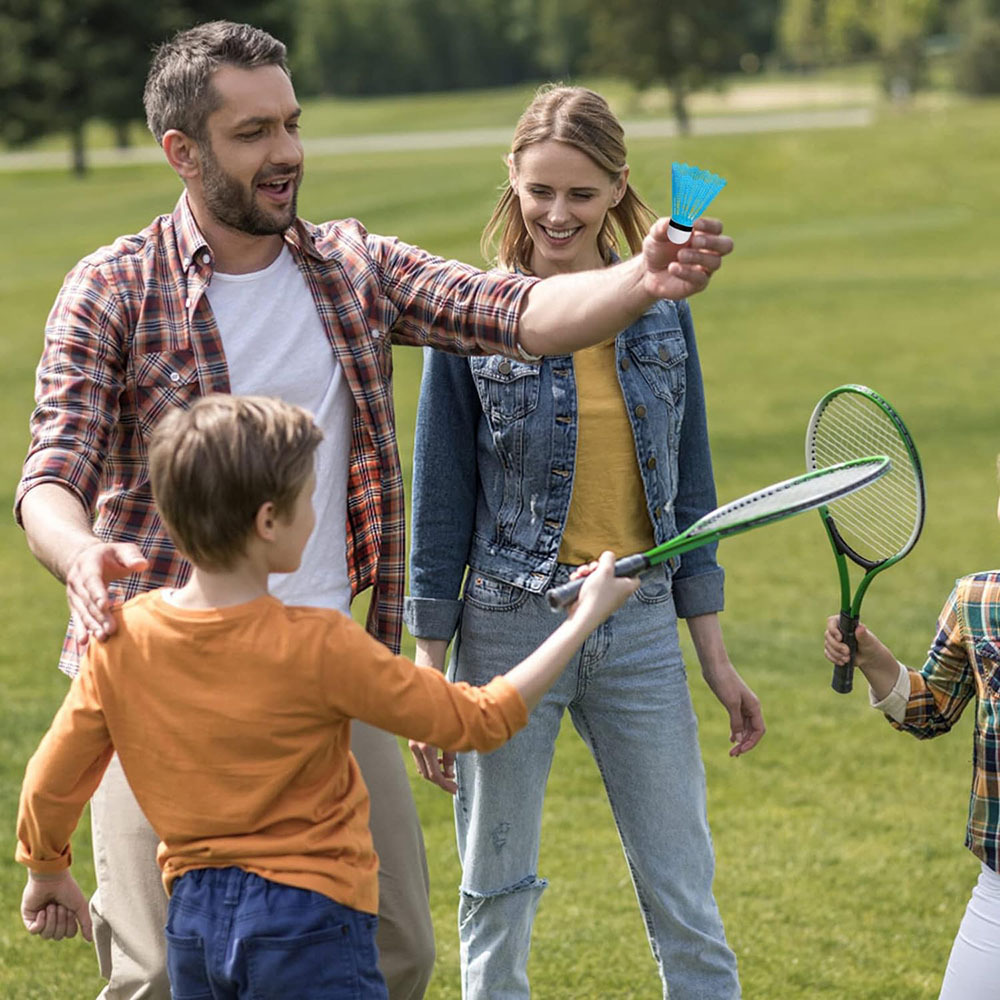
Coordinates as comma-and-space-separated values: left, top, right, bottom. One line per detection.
0, 0, 290, 176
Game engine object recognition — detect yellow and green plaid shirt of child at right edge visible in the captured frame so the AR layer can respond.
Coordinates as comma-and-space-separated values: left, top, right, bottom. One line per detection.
889, 571, 1000, 872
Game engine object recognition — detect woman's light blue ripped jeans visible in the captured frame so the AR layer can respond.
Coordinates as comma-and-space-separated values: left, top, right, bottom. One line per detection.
450, 567, 740, 1000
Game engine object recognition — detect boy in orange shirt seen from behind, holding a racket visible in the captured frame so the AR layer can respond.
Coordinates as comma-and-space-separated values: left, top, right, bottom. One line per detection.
17, 396, 637, 998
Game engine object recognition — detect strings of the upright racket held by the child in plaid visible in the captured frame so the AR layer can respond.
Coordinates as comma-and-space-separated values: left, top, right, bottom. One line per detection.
810, 394, 923, 563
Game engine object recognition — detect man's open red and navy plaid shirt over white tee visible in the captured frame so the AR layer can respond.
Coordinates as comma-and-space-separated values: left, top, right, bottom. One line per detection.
14, 195, 531, 675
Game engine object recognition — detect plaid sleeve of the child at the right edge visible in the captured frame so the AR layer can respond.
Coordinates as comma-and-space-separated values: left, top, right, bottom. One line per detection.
890, 586, 976, 739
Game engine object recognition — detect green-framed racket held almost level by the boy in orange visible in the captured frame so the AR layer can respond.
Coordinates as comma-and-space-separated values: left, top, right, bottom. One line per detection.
546, 455, 889, 611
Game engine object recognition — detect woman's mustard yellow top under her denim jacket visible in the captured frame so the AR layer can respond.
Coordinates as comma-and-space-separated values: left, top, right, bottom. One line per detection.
559, 339, 653, 565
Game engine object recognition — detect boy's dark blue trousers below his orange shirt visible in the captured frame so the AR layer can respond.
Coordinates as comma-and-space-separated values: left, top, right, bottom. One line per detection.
167, 868, 388, 1000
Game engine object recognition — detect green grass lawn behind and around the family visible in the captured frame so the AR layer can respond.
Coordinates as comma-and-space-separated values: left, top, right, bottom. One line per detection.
0, 88, 1000, 1000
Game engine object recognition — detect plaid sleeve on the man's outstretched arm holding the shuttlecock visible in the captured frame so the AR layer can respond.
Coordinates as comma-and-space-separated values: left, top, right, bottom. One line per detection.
367, 234, 538, 355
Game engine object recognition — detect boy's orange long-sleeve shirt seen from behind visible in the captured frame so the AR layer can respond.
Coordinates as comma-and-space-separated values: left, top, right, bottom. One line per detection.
17, 591, 527, 913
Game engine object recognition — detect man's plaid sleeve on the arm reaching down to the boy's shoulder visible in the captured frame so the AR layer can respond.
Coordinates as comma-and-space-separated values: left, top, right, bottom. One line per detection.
14, 261, 125, 523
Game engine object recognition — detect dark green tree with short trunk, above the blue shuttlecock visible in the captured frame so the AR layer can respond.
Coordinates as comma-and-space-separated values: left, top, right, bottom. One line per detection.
590, 0, 759, 131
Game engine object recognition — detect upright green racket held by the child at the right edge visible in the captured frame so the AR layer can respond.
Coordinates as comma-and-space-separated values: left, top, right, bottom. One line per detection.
806, 385, 925, 694
